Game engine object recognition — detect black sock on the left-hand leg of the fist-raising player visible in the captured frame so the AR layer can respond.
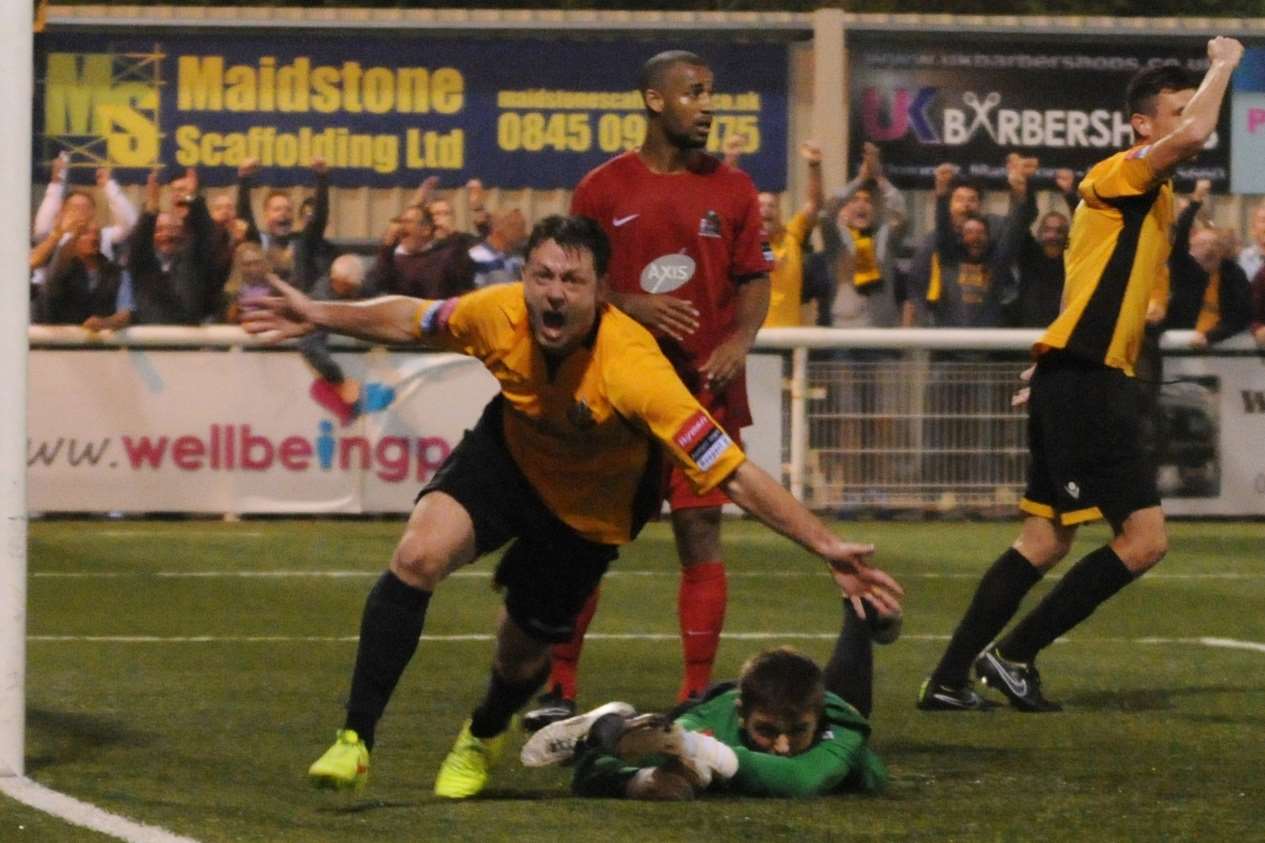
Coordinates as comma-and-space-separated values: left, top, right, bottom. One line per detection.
931, 548, 1042, 687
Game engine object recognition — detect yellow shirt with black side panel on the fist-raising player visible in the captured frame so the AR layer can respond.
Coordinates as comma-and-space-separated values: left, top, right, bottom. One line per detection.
1034, 146, 1173, 376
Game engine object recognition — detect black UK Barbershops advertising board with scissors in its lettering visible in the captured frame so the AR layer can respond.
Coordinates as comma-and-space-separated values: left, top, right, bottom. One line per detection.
848, 33, 1231, 191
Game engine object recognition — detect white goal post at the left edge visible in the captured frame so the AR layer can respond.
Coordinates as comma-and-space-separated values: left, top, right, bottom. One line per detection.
0, 0, 34, 777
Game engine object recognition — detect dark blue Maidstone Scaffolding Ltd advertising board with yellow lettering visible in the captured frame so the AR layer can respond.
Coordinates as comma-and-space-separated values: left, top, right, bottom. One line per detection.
33, 33, 788, 190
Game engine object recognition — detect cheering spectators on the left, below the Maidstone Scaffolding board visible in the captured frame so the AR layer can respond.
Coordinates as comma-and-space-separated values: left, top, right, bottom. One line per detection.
30, 156, 528, 424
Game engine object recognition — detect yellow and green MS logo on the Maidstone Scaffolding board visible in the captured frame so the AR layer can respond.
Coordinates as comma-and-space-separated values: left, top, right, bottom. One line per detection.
44, 47, 163, 167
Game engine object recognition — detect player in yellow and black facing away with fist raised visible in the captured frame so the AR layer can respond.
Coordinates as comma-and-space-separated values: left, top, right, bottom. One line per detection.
917, 38, 1243, 711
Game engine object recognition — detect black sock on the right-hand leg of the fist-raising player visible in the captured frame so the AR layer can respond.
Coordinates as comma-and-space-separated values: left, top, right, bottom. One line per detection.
997, 546, 1135, 662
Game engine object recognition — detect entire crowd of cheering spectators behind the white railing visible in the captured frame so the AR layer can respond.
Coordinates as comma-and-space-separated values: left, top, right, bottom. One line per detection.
30, 141, 1265, 346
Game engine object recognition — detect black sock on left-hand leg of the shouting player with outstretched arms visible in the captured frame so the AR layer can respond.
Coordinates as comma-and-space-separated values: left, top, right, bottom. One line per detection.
344, 571, 430, 749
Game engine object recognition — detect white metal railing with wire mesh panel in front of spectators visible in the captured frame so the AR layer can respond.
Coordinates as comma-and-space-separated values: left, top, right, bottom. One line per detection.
29, 325, 1224, 514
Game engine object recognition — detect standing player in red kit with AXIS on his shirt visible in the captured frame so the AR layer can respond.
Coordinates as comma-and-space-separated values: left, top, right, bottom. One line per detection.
525, 51, 772, 729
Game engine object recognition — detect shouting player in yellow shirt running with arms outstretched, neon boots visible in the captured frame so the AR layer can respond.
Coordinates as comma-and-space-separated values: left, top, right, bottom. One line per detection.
243, 216, 899, 799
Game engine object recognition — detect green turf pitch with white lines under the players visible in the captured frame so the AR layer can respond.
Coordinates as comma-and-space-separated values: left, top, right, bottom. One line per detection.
9, 521, 1265, 843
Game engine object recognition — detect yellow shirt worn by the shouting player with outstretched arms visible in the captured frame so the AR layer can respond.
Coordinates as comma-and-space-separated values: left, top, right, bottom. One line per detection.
414, 282, 746, 544
